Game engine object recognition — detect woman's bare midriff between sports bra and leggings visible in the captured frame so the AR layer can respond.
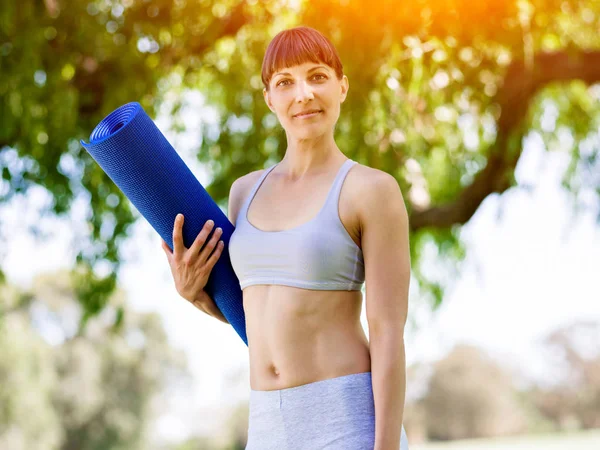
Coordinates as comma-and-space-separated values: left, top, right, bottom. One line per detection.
243, 285, 371, 391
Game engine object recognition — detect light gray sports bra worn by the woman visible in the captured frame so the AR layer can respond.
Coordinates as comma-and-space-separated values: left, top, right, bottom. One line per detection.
229, 159, 365, 291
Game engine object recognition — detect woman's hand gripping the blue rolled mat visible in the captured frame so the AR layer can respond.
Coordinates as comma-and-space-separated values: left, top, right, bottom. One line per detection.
162, 214, 225, 315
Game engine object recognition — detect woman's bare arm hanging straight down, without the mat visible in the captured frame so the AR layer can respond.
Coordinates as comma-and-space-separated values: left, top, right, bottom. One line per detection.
360, 171, 410, 450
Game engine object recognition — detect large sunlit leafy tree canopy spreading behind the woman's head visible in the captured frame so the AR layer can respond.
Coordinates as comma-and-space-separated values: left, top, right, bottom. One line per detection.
0, 0, 600, 317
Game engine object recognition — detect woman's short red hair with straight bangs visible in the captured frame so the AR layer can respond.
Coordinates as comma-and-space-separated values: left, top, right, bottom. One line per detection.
261, 26, 344, 91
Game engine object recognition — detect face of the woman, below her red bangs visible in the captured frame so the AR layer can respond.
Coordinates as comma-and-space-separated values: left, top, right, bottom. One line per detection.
263, 62, 348, 139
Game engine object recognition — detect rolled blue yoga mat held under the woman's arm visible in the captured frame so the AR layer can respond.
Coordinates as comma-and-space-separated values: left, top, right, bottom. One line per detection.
81, 102, 248, 345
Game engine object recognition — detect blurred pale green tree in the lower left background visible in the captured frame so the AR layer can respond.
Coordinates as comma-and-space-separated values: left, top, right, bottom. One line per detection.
0, 272, 186, 450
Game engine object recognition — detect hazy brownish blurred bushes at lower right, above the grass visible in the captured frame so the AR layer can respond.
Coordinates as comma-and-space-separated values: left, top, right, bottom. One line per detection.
404, 320, 600, 443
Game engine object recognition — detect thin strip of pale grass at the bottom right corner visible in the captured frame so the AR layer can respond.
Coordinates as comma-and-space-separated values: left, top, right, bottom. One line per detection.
409, 429, 600, 450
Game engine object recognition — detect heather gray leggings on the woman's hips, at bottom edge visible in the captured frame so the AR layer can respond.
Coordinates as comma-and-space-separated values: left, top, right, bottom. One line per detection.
246, 372, 408, 450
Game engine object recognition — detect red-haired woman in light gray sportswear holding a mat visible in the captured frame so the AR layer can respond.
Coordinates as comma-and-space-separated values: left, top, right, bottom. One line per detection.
163, 27, 410, 450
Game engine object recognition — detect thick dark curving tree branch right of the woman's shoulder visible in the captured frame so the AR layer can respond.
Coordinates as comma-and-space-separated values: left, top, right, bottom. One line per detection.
410, 51, 600, 231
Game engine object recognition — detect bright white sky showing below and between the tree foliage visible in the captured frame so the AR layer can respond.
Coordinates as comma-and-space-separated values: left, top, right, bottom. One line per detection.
0, 94, 600, 440
